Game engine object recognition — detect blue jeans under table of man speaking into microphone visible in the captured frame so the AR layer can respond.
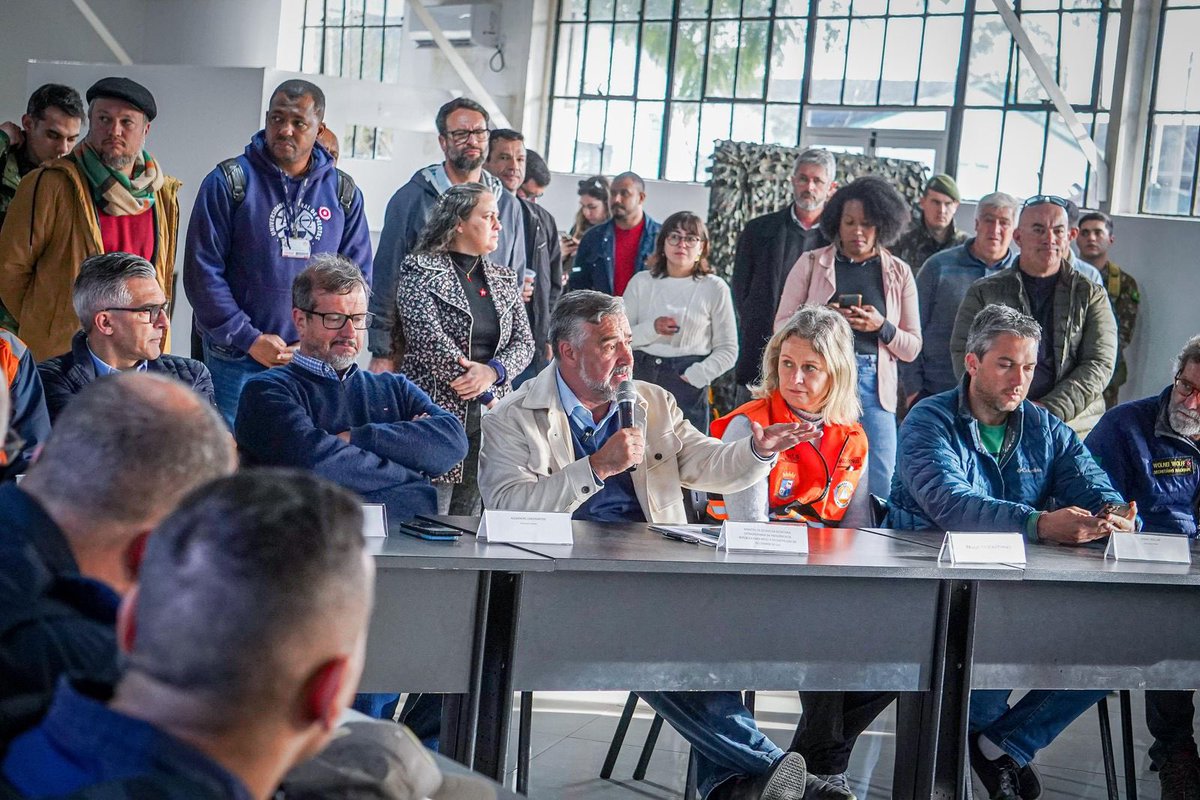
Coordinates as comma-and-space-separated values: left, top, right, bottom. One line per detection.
637, 692, 784, 798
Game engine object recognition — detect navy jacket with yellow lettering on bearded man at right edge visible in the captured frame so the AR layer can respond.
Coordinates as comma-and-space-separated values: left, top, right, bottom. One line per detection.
1084, 386, 1200, 536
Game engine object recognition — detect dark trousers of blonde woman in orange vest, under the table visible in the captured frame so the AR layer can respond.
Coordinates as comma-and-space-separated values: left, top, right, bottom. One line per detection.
788, 692, 896, 775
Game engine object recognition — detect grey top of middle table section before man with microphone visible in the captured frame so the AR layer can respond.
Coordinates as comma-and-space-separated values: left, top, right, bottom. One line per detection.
492, 522, 1020, 581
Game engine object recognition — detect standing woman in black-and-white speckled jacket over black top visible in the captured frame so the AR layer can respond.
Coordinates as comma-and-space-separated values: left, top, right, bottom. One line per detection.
392, 184, 533, 516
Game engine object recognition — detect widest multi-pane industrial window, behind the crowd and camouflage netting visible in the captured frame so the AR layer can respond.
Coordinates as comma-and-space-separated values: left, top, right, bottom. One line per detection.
548, 0, 1118, 204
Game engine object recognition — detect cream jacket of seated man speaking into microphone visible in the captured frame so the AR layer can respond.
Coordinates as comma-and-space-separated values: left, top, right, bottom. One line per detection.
479, 362, 773, 524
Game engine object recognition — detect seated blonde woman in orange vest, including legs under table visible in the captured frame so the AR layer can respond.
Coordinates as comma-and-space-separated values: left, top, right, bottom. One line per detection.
709, 306, 878, 796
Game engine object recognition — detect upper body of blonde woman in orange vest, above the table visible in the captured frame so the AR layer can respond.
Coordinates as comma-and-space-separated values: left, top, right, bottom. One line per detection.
709, 306, 871, 528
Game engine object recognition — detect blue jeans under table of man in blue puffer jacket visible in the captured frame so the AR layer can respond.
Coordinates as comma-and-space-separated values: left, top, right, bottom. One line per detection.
968, 688, 1108, 766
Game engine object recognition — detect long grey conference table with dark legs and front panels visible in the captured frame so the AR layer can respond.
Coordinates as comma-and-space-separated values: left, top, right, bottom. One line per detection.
362, 517, 1200, 799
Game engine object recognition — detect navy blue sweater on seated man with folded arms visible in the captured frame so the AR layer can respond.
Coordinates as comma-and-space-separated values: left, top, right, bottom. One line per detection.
234, 363, 467, 521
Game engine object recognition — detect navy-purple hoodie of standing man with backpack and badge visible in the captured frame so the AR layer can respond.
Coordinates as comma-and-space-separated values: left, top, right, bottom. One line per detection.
184, 131, 371, 353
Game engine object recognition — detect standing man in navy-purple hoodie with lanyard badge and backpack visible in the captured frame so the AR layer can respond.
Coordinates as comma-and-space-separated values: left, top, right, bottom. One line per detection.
184, 80, 371, 427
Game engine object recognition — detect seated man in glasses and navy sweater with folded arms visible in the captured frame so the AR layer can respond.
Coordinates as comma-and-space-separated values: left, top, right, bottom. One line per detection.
234, 254, 467, 521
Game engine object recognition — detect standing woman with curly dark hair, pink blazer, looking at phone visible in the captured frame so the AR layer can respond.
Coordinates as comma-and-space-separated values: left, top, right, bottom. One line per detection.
775, 175, 920, 498
